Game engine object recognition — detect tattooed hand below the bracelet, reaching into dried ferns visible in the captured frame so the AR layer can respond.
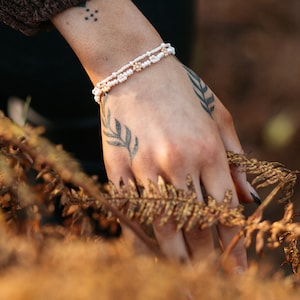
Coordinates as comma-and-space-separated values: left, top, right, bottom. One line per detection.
101, 57, 255, 269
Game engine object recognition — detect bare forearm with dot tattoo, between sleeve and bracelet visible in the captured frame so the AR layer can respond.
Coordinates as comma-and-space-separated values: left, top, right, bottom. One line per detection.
52, 0, 161, 84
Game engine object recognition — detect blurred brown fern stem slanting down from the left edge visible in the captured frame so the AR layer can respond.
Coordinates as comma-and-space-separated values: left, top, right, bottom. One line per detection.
0, 112, 160, 255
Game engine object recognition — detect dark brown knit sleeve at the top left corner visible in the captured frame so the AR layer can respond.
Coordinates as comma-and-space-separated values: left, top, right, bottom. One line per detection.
0, 0, 88, 35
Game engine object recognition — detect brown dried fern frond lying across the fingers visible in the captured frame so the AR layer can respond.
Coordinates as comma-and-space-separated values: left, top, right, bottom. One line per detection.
100, 177, 244, 230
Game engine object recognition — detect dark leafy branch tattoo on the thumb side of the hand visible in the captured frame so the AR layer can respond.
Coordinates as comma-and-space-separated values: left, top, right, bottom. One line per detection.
184, 66, 215, 117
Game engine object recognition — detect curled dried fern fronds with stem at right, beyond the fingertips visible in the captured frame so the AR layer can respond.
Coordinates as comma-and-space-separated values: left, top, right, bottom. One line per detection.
225, 152, 300, 274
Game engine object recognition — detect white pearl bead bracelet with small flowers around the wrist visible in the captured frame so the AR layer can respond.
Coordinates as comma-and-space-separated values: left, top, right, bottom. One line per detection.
92, 43, 175, 104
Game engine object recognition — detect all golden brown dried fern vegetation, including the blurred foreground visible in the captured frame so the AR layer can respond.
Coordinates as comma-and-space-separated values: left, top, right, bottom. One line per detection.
0, 110, 300, 299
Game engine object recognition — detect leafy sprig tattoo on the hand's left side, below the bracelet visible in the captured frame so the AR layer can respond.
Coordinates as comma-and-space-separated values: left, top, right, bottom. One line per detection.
101, 94, 139, 162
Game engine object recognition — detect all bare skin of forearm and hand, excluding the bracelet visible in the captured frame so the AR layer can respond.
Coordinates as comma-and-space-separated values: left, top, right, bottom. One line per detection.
52, 0, 255, 269
